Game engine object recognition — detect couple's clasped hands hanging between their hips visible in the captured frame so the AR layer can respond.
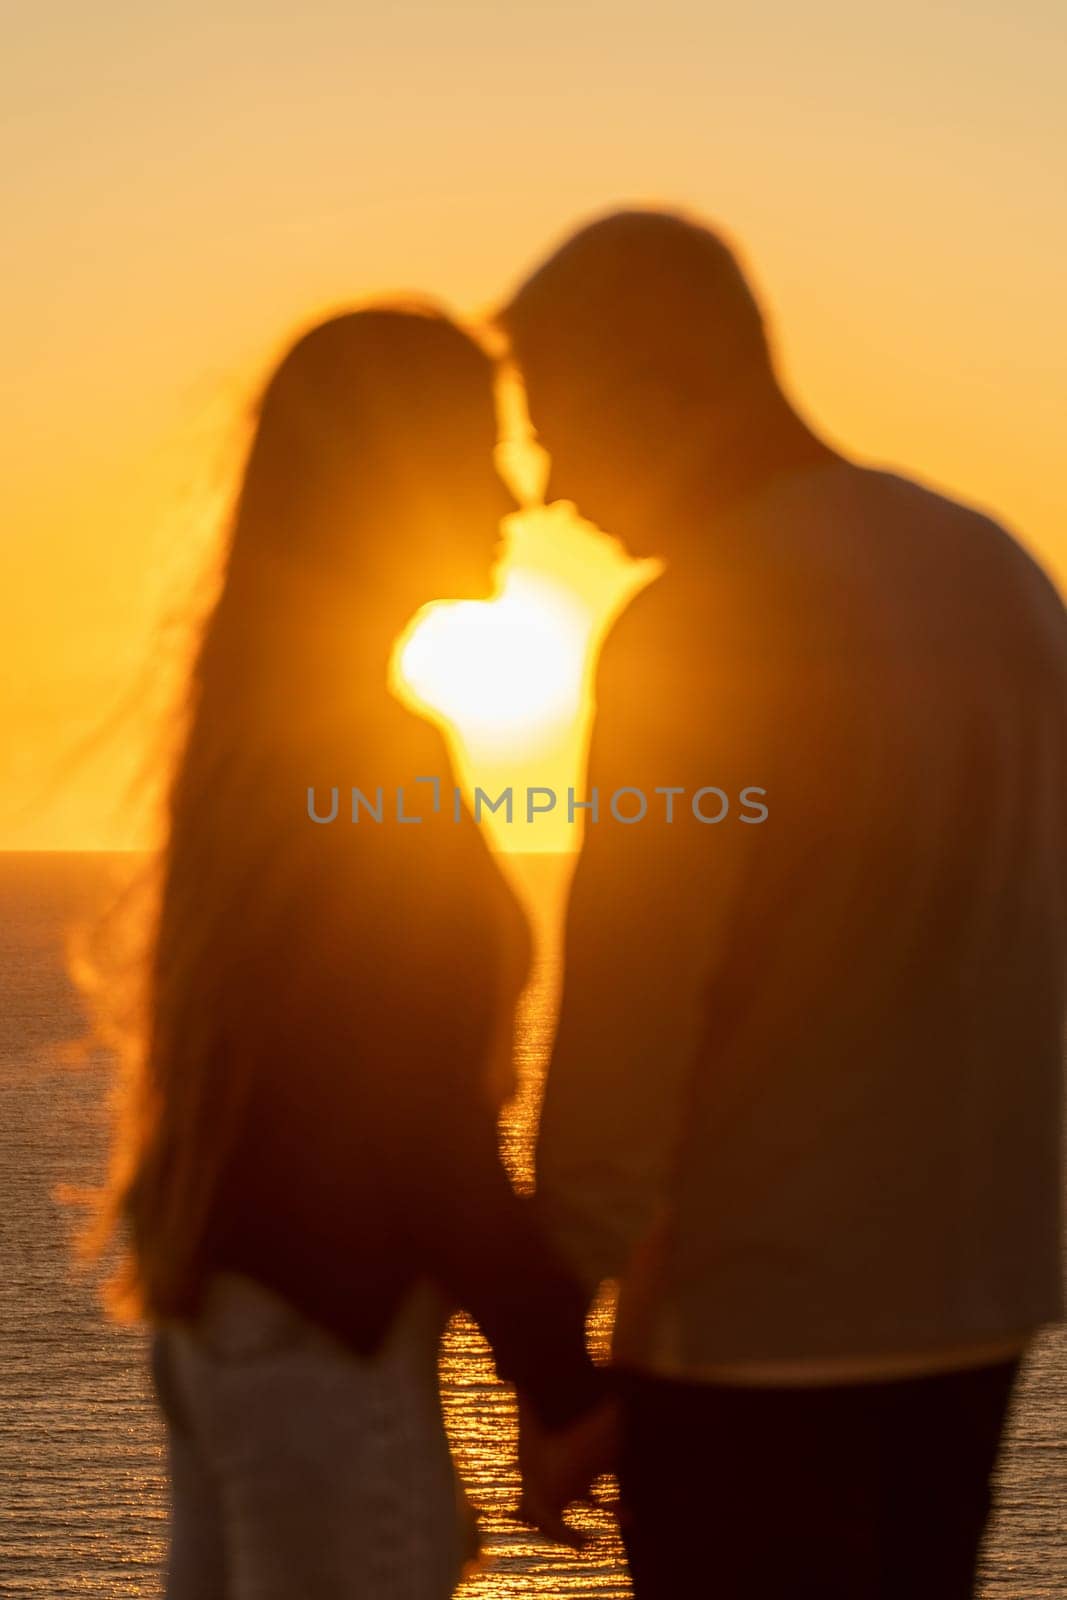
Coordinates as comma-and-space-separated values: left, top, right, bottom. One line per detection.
518, 1395, 619, 1550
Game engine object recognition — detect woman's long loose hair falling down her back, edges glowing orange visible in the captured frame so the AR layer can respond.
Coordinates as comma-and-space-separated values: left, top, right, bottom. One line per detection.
93, 304, 493, 1318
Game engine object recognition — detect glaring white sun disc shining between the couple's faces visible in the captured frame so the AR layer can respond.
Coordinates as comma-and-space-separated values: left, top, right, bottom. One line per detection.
397, 568, 592, 749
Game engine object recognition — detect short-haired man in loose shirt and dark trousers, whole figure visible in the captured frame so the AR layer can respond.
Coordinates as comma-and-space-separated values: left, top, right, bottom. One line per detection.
501, 213, 1067, 1600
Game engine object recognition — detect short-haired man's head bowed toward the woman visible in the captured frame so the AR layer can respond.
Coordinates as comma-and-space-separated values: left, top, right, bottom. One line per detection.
498, 211, 773, 554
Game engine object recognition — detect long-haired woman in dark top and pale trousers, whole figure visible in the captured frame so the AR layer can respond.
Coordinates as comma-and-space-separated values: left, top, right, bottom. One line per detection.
99, 307, 600, 1600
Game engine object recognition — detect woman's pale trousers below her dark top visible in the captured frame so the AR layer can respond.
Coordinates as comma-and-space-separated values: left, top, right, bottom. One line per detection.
152, 1274, 472, 1600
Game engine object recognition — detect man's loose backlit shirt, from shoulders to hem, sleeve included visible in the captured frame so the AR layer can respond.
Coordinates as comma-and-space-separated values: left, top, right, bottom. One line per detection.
539, 462, 1067, 1371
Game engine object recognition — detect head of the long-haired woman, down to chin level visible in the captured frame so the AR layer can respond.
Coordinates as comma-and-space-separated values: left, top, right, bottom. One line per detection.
221, 306, 515, 688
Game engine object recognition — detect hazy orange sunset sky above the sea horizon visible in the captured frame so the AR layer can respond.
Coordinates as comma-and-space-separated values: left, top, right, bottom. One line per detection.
0, 0, 1067, 848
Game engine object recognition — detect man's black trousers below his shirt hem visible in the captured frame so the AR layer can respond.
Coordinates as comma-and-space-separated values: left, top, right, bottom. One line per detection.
619, 1362, 1019, 1600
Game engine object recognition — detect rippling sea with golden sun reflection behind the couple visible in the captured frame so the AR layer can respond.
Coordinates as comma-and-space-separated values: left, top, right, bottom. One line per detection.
0, 853, 1067, 1600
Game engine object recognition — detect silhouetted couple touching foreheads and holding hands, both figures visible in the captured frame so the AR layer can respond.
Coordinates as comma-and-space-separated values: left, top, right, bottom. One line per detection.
103, 213, 1067, 1600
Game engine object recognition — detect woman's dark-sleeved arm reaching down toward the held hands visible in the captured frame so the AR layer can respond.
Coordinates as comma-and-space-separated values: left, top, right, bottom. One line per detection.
385, 821, 605, 1426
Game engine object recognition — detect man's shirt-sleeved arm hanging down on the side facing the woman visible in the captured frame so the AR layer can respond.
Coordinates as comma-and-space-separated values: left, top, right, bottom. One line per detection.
537, 598, 760, 1288
